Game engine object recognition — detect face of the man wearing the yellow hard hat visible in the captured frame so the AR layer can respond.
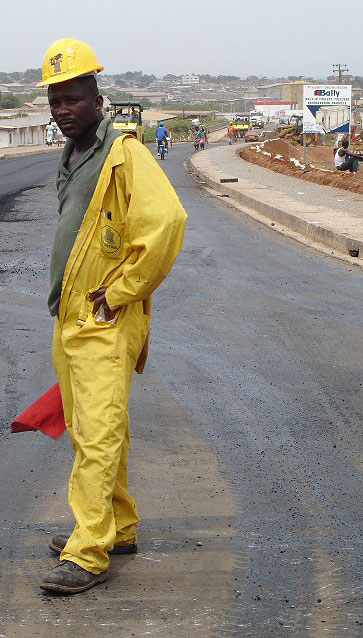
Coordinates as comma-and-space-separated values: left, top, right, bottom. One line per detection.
48, 78, 103, 138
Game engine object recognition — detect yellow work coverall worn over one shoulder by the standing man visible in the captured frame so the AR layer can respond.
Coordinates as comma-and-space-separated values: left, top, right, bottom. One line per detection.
53, 136, 186, 574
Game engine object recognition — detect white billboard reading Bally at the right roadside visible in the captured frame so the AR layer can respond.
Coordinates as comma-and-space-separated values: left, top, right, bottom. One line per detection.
303, 84, 352, 133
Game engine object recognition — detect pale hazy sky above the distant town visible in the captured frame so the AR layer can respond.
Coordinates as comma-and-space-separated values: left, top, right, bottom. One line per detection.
0, 0, 363, 78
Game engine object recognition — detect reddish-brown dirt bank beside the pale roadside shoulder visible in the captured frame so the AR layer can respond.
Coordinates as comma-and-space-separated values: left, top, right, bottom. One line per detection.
239, 139, 363, 193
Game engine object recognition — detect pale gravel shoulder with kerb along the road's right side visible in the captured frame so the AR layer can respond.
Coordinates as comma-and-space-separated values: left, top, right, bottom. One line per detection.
188, 145, 363, 267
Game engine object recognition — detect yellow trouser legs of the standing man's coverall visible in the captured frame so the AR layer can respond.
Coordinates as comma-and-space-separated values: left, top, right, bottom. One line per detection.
53, 292, 148, 574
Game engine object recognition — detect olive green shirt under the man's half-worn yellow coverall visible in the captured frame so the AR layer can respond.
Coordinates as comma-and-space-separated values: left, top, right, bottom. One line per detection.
48, 119, 121, 317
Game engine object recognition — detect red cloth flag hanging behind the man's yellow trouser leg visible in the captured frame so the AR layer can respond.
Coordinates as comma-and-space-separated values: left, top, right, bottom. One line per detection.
11, 383, 66, 439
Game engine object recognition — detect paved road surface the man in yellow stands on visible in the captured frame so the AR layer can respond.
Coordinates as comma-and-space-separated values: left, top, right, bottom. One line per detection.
0, 146, 363, 638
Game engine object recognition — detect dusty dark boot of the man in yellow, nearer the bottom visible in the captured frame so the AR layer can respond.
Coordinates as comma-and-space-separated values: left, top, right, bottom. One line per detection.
39, 560, 108, 594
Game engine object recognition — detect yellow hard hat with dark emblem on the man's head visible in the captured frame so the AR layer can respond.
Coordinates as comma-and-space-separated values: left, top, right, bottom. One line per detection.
37, 38, 104, 86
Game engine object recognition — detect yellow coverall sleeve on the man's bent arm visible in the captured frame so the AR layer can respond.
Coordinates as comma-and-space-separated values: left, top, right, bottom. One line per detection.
106, 139, 187, 310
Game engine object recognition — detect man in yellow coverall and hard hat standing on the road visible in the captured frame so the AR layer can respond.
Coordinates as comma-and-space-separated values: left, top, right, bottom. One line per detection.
40, 39, 186, 594
